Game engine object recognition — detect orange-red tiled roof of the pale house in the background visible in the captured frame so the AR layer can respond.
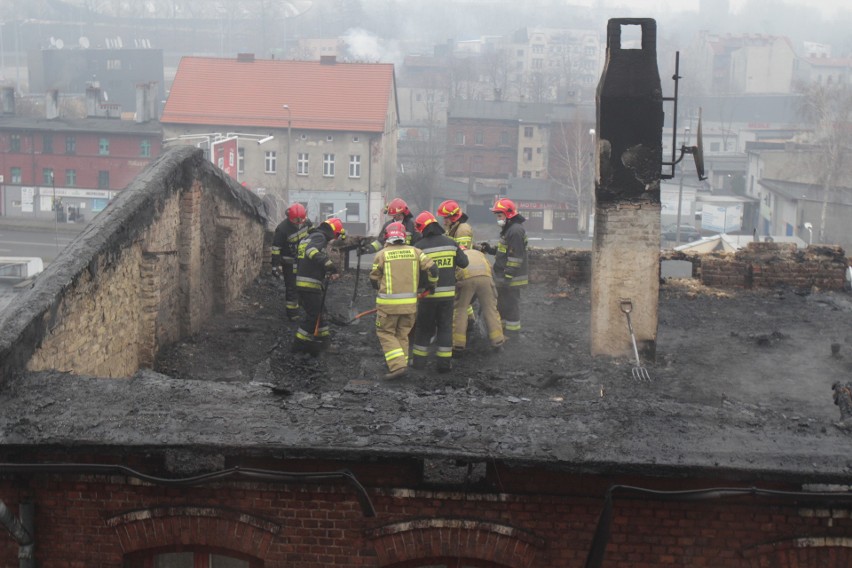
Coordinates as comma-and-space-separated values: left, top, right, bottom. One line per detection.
160, 57, 396, 132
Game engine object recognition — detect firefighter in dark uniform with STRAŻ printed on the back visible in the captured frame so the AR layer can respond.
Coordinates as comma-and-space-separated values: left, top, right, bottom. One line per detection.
411, 211, 467, 373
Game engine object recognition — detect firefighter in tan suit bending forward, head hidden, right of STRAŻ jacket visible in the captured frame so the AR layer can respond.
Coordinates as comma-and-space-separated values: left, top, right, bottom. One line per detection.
453, 247, 506, 356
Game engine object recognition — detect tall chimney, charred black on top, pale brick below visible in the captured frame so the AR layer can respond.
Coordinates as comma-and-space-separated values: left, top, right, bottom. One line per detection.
591, 18, 663, 361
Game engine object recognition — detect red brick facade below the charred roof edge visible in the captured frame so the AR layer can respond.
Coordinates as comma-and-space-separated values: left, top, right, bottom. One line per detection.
0, 456, 852, 568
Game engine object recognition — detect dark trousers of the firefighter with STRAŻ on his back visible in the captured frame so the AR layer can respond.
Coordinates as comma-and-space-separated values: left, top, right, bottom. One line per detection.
411, 298, 456, 371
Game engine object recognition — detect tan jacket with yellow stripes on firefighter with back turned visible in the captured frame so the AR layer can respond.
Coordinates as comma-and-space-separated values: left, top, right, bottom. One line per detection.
370, 244, 438, 314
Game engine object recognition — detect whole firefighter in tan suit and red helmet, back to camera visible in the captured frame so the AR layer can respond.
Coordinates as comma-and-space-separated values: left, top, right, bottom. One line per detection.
370, 222, 438, 379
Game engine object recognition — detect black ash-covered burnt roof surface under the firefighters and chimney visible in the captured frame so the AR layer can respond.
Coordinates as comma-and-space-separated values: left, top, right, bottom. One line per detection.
0, 261, 852, 480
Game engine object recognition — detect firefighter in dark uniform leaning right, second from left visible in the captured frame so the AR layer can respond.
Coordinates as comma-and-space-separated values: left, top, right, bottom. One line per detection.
293, 217, 346, 357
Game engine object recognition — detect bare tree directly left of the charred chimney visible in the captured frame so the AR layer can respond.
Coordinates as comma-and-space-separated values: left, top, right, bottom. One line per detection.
547, 118, 595, 233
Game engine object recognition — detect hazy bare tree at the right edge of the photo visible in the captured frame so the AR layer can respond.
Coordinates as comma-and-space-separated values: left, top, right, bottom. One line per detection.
799, 84, 852, 243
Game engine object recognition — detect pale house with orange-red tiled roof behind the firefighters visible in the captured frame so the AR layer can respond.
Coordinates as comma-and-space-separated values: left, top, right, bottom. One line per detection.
161, 54, 399, 235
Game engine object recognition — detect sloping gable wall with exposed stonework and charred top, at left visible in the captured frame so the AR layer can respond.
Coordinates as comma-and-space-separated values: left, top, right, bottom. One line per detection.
0, 148, 266, 380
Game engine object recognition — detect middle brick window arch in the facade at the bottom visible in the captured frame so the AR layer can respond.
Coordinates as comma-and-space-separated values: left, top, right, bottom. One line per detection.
367, 518, 544, 568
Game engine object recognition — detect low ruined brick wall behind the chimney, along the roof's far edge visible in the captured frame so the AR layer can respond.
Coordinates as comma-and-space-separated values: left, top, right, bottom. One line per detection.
530, 243, 852, 290
